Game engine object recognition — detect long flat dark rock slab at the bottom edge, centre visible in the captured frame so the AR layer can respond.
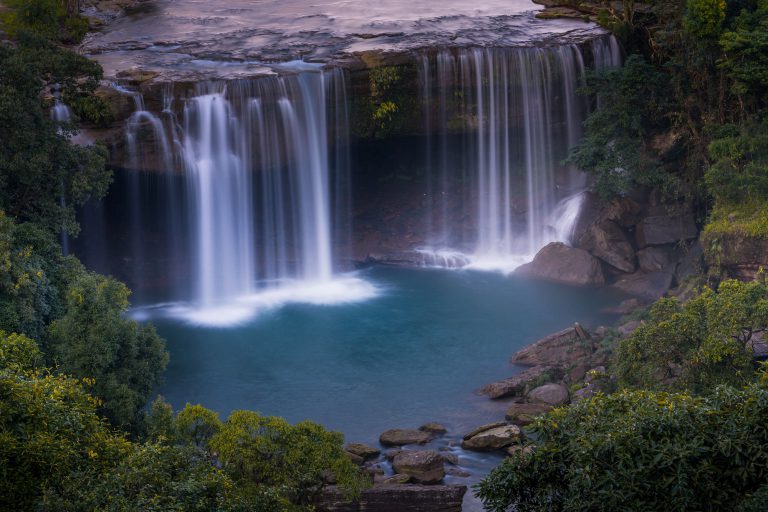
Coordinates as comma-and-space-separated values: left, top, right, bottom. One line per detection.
316, 484, 467, 512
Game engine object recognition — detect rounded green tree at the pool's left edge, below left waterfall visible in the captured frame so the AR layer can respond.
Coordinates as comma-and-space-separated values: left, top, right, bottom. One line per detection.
46, 273, 168, 428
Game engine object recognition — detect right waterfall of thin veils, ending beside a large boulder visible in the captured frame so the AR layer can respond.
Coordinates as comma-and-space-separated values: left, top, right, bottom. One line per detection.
421, 37, 621, 270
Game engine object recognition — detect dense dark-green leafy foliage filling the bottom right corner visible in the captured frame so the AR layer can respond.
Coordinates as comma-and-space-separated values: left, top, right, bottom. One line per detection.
479, 382, 768, 512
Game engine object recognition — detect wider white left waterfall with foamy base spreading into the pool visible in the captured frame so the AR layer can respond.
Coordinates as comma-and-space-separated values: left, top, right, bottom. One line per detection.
100, 63, 373, 324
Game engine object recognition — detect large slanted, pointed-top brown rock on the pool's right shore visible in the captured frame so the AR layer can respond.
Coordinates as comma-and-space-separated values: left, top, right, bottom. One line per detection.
512, 327, 594, 367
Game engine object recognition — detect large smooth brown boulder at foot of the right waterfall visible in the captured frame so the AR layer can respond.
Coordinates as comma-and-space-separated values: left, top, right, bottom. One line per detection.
515, 242, 605, 286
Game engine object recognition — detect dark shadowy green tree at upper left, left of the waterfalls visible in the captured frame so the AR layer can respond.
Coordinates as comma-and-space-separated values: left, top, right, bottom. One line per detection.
0, 34, 112, 235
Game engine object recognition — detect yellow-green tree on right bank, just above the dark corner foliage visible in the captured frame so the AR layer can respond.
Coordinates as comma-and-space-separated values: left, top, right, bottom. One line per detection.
615, 279, 768, 392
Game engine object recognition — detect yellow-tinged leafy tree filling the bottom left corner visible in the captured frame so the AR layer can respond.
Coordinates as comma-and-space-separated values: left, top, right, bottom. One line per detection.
0, 335, 129, 511
